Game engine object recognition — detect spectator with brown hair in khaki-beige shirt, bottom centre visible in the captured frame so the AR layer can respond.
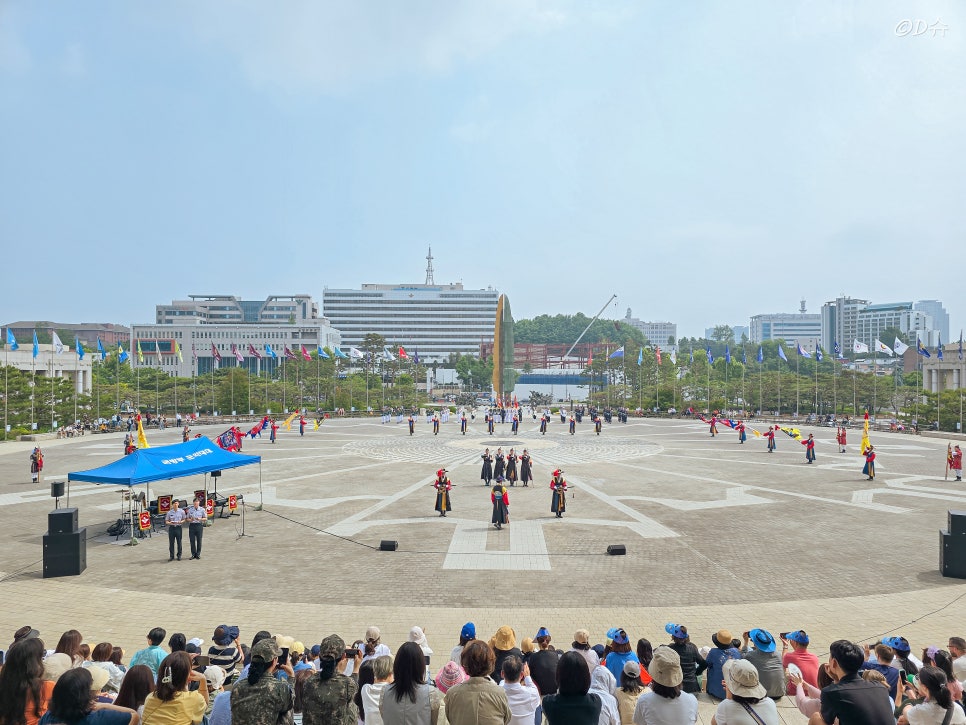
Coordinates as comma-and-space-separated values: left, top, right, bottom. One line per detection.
444, 640, 510, 725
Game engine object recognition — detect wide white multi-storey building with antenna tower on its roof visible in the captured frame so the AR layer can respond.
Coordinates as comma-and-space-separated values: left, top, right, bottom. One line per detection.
322, 249, 500, 362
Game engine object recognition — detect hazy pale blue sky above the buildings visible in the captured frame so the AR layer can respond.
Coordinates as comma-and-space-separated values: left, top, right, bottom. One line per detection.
0, 0, 966, 336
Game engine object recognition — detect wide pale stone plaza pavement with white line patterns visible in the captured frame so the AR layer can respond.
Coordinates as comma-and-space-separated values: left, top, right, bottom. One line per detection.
0, 417, 966, 722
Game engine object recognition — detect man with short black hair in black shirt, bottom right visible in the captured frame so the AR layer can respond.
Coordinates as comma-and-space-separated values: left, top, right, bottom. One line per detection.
808, 639, 895, 725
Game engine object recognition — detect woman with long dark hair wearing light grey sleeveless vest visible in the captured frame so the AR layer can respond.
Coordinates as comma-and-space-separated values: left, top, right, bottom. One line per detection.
379, 642, 443, 725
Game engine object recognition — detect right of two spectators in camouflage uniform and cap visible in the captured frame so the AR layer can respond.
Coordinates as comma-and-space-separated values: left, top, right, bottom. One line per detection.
302, 634, 360, 725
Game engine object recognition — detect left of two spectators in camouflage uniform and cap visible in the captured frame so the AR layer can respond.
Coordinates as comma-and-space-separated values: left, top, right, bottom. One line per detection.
230, 637, 292, 725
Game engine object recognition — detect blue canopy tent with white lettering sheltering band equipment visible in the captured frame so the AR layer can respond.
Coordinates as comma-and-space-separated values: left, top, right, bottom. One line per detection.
67, 438, 262, 530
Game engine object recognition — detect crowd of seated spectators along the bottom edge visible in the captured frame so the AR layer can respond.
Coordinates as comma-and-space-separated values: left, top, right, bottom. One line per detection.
0, 622, 966, 725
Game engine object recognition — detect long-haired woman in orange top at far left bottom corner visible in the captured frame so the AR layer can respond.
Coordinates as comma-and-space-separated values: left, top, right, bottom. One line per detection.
0, 637, 54, 725
